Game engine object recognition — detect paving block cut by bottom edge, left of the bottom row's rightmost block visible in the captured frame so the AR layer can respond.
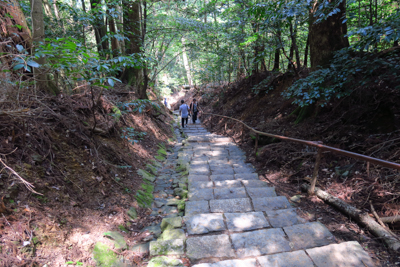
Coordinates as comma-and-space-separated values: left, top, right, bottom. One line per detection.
257, 250, 316, 267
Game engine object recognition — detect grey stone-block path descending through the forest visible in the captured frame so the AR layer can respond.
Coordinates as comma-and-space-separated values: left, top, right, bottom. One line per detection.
149, 114, 374, 267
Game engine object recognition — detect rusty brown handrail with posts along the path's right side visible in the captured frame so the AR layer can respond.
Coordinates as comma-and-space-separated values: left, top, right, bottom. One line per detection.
203, 112, 400, 194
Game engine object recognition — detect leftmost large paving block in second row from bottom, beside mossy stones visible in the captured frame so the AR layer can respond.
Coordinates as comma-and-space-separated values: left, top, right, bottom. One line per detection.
186, 235, 235, 261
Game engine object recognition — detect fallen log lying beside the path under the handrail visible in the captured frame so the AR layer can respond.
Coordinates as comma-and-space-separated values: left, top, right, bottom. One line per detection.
302, 184, 400, 251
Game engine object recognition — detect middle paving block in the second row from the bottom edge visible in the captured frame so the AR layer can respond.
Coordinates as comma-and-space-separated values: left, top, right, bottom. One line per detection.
231, 228, 291, 258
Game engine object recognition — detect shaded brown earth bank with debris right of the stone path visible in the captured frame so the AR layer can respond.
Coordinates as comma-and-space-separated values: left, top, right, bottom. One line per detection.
186, 71, 400, 266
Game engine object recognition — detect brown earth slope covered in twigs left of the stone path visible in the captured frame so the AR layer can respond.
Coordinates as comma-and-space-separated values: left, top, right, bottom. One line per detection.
0, 85, 173, 266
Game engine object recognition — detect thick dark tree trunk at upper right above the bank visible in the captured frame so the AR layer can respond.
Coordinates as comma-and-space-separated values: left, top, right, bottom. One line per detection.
309, 0, 349, 70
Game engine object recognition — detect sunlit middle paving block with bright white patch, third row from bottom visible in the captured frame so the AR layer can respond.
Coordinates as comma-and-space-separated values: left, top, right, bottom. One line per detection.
224, 212, 270, 232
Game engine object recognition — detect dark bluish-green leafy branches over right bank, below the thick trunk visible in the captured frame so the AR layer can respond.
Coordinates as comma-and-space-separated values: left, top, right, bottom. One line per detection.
282, 49, 400, 107
